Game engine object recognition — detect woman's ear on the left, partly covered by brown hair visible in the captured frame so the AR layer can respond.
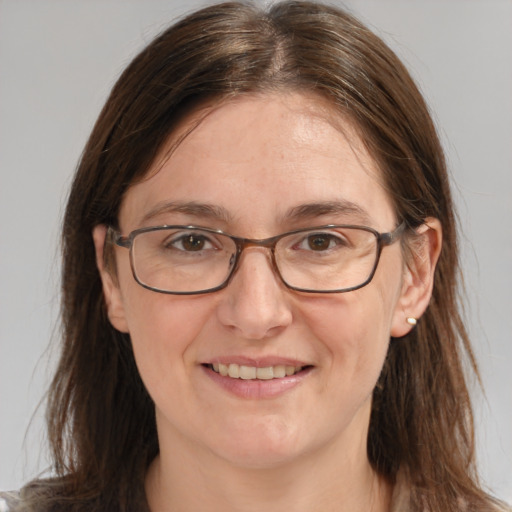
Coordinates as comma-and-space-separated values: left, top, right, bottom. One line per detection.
92, 224, 128, 333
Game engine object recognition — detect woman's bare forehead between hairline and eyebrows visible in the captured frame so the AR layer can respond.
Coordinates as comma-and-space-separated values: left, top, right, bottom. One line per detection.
120, 93, 393, 233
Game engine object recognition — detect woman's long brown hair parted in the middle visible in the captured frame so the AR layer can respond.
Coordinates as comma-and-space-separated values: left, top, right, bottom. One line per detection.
22, 1, 502, 512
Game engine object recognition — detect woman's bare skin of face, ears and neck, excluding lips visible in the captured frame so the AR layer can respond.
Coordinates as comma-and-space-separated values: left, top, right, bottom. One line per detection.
93, 93, 441, 512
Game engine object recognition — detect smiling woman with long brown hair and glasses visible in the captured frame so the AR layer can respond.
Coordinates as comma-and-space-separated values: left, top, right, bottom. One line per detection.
3, 2, 508, 512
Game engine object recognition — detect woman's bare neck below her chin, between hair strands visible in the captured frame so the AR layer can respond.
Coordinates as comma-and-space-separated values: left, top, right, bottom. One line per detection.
146, 422, 391, 512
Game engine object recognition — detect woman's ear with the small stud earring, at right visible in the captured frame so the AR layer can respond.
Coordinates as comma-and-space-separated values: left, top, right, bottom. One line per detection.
391, 217, 443, 338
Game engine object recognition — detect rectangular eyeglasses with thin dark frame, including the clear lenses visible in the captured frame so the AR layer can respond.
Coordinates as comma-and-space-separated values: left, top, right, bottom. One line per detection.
109, 223, 405, 295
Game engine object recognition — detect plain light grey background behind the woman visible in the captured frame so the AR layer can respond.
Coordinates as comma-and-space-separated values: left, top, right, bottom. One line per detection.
0, 0, 512, 502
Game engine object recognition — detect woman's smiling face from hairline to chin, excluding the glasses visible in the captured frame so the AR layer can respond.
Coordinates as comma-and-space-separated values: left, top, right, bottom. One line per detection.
99, 94, 412, 467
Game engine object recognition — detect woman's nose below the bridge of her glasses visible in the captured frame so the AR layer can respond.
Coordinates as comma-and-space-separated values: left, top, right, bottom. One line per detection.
217, 247, 292, 340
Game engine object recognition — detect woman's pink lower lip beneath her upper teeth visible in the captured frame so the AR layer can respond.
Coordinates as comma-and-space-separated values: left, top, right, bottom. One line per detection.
202, 366, 312, 400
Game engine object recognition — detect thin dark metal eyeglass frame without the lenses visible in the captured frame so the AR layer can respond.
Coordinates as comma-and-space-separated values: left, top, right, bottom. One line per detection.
107, 222, 406, 295
